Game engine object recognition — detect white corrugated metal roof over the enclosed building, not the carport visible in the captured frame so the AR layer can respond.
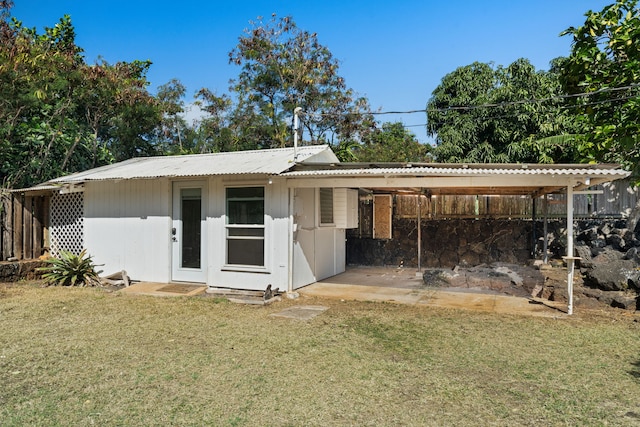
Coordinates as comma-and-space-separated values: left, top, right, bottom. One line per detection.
49, 145, 338, 183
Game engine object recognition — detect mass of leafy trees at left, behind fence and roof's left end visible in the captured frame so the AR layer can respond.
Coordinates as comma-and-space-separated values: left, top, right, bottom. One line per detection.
0, 5, 159, 187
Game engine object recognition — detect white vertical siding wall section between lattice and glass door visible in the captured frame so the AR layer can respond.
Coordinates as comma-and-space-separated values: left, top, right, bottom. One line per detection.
85, 179, 171, 282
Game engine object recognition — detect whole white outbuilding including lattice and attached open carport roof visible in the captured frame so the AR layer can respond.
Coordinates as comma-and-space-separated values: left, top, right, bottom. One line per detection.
32, 145, 629, 310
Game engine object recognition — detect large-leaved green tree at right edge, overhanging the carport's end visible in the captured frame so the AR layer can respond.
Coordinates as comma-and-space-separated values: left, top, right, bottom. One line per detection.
561, 0, 640, 175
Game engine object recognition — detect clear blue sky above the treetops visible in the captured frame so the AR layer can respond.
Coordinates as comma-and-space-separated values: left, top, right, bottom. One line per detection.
12, 0, 614, 142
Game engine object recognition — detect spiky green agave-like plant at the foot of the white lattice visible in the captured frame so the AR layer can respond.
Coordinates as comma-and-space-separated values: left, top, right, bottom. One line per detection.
38, 249, 102, 286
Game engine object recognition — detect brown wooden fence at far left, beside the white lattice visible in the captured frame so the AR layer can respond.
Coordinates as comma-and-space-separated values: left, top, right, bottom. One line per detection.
0, 193, 50, 260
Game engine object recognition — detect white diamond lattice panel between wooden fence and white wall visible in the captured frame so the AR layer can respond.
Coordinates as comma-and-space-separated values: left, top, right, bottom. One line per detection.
51, 193, 84, 257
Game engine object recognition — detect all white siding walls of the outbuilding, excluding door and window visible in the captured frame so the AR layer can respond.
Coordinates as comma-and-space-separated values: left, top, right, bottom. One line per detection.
85, 177, 345, 290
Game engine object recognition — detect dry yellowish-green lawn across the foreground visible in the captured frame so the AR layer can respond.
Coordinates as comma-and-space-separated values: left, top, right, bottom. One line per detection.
0, 284, 640, 426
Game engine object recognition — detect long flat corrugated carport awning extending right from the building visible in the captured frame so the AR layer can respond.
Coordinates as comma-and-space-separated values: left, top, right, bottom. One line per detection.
281, 163, 629, 196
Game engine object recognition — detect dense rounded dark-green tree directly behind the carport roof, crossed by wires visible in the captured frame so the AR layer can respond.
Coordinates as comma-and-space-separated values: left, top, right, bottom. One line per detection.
427, 59, 575, 163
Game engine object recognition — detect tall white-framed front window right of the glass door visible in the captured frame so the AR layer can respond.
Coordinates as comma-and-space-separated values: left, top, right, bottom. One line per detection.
226, 187, 264, 267
